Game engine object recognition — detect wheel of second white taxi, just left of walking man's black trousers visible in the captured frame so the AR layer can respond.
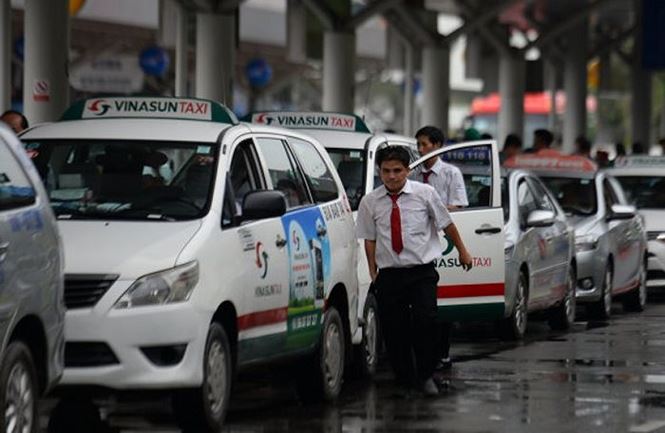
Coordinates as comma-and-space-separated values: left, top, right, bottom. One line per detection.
350, 293, 381, 378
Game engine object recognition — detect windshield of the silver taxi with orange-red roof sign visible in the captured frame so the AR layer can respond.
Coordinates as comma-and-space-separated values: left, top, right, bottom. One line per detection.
541, 176, 598, 216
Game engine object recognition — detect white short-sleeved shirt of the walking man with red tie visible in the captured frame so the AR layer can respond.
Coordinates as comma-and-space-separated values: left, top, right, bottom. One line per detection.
356, 180, 452, 269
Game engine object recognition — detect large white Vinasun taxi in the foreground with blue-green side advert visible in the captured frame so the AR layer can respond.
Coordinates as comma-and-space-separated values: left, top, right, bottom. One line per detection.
21, 97, 358, 431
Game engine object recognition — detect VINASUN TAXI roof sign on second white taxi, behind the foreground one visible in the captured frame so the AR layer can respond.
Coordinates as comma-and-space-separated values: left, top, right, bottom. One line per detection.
243, 111, 371, 134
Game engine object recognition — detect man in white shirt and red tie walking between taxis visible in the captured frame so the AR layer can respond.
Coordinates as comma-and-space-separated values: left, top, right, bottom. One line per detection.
357, 146, 472, 396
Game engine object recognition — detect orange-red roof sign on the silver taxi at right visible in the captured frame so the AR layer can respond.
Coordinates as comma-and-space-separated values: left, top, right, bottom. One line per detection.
503, 150, 598, 173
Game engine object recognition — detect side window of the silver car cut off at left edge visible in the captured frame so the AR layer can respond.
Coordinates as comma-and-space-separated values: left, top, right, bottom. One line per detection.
0, 142, 35, 210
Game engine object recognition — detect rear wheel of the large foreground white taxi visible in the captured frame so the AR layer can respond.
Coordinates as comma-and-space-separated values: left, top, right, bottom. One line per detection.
296, 307, 345, 402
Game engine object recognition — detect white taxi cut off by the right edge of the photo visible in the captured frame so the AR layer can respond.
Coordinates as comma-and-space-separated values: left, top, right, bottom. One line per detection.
607, 156, 665, 287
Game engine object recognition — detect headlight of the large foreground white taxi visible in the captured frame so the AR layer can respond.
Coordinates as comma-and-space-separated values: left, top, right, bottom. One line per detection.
113, 261, 199, 309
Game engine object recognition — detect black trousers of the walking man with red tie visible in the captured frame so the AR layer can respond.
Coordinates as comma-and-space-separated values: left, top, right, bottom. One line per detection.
375, 264, 440, 386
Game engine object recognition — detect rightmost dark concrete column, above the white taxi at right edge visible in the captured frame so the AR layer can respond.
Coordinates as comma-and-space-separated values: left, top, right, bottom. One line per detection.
630, 2, 651, 148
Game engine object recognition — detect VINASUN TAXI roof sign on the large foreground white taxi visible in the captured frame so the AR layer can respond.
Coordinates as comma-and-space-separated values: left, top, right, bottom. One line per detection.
61, 96, 238, 124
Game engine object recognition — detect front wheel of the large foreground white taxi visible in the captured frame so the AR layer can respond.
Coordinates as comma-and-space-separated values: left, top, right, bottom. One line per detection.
173, 322, 233, 432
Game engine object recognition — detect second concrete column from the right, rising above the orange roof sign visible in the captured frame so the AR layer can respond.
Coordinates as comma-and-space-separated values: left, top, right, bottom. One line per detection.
563, 21, 589, 152
